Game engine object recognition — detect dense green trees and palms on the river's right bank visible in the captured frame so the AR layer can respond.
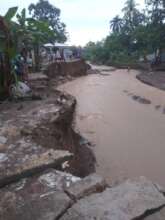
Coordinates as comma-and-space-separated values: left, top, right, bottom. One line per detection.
84, 0, 165, 66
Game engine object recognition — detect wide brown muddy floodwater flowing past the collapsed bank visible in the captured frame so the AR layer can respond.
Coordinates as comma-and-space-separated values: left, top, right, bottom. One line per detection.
60, 67, 165, 187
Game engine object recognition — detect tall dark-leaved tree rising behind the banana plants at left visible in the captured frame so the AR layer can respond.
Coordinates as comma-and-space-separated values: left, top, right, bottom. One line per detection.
29, 0, 67, 42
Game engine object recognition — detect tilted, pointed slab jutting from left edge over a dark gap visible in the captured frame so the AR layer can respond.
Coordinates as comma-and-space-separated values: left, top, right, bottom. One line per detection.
0, 139, 72, 187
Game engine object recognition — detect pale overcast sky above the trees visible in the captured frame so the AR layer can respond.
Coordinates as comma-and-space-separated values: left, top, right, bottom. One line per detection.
0, 0, 144, 45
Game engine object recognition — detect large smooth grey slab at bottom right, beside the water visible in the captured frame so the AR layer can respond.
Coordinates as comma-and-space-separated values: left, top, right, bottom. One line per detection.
61, 177, 165, 220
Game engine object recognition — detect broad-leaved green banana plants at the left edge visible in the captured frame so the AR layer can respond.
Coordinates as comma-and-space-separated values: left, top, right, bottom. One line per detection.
0, 7, 54, 97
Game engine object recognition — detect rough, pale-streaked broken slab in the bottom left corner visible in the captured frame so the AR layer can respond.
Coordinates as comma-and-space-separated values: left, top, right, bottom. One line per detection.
0, 169, 74, 220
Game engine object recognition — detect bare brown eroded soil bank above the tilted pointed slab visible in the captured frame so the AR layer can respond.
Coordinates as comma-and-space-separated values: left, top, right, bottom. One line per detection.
0, 59, 95, 185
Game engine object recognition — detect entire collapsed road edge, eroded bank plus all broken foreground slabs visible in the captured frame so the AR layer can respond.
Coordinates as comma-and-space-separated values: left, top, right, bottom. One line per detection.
0, 60, 165, 220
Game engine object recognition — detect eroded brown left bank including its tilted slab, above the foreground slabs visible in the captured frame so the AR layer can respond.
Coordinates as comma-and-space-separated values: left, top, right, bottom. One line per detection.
0, 59, 95, 185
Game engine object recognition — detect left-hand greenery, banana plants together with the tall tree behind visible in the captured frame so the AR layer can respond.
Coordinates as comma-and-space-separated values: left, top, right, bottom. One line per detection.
0, 0, 67, 96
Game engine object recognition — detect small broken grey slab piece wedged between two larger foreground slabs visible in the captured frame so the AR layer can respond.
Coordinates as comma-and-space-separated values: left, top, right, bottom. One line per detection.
65, 174, 106, 200
